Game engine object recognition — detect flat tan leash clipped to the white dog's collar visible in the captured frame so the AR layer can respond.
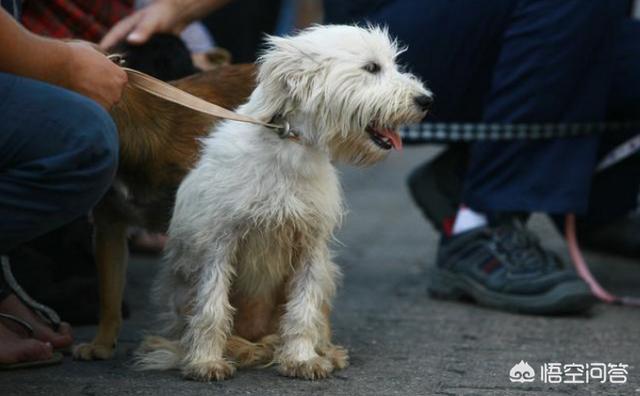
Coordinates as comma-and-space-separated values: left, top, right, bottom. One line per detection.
107, 54, 299, 140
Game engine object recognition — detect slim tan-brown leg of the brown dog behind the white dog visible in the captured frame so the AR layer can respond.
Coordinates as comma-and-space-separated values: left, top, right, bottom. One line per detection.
73, 209, 128, 360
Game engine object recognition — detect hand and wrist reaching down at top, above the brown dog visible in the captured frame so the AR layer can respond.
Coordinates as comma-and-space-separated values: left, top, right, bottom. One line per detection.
100, 0, 231, 49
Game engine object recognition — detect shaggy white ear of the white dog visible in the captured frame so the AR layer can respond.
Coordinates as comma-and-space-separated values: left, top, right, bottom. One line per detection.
258, 36, 317, 115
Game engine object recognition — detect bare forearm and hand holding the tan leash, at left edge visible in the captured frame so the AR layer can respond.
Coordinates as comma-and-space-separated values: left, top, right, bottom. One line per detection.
0, 8, 127, 109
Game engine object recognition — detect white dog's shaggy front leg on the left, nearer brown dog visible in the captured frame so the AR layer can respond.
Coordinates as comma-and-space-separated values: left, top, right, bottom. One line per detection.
180, 241, 235, 381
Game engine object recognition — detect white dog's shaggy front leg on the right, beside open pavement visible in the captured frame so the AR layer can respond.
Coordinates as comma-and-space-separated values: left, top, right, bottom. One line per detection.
276, 246, 338, 380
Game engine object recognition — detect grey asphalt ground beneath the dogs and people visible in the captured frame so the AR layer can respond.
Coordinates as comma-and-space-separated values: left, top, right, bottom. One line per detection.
0, 148, 640, 396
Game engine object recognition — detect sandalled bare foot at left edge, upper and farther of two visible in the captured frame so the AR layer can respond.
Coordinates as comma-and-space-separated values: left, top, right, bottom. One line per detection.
0, 294, 73, 349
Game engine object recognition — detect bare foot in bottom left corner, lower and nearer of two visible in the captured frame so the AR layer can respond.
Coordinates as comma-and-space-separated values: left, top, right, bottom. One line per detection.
0, 323, 53, 364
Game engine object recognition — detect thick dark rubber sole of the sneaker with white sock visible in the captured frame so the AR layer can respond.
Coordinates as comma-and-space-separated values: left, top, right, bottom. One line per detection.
427, 268, 596, 315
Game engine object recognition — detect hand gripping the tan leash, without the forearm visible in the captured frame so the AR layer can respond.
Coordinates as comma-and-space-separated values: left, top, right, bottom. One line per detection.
61, 41, 127, 110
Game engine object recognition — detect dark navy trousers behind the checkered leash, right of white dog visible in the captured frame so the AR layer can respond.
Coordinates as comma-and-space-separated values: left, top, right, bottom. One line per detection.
325, 0, 640, 216
